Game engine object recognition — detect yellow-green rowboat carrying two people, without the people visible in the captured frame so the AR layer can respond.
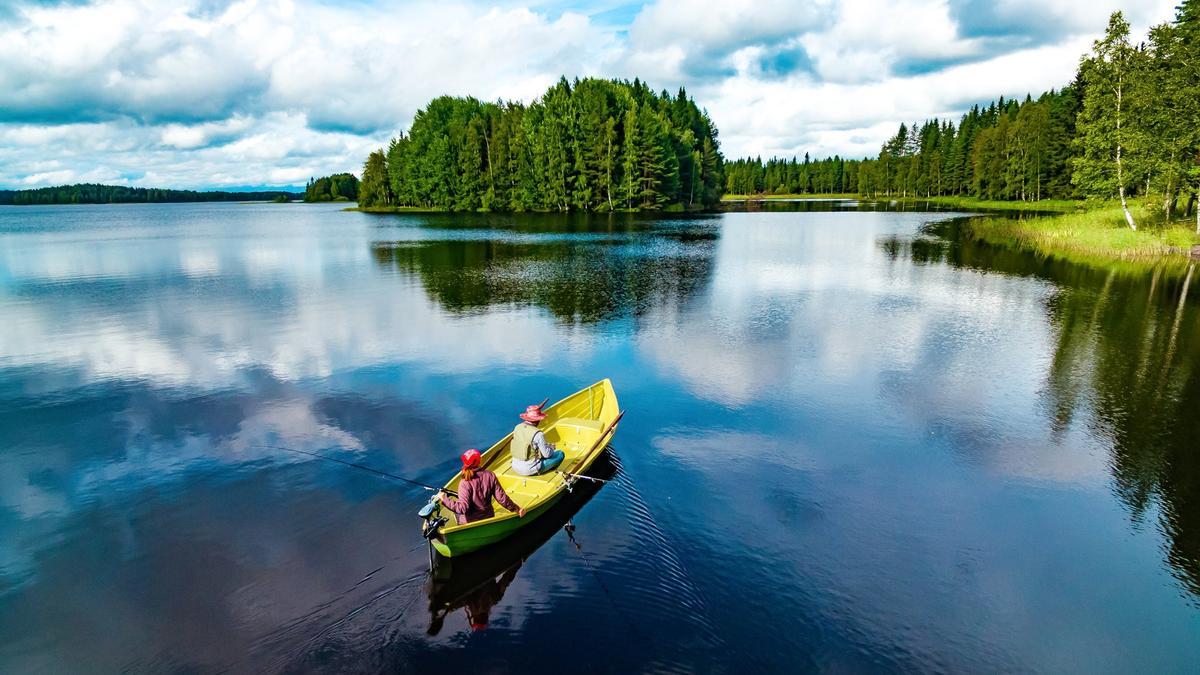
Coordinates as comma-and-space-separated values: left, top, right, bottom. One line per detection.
421, 380, 622, 557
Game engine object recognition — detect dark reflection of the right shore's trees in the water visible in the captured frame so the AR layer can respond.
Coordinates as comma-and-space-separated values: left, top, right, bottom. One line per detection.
880, 221, 1200, 596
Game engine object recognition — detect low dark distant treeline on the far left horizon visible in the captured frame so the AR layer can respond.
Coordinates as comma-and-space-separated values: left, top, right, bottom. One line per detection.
0, 183, 300, 205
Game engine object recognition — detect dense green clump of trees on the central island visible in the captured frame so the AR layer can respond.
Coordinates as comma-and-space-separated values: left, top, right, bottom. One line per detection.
359, 78, 725, 211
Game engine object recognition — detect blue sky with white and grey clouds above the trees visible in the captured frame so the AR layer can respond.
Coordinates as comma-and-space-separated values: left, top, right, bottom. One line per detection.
0, 0, 1175, 189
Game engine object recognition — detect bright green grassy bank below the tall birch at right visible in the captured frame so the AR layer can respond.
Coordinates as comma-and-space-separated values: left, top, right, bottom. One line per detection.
967, 207, 1200, 264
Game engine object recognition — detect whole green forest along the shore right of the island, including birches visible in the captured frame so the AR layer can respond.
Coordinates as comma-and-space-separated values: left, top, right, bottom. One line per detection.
726, 0, 1200, 226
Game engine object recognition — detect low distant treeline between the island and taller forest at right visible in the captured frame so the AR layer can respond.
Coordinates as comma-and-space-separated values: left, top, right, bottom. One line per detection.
725, 154, 862, 195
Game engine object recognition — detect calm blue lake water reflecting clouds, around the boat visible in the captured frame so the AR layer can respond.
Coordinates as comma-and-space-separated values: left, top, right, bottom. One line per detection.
0, 203, 1200, 673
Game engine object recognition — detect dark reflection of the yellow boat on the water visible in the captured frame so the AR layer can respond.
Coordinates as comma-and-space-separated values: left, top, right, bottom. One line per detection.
426, 448, 617, 635
